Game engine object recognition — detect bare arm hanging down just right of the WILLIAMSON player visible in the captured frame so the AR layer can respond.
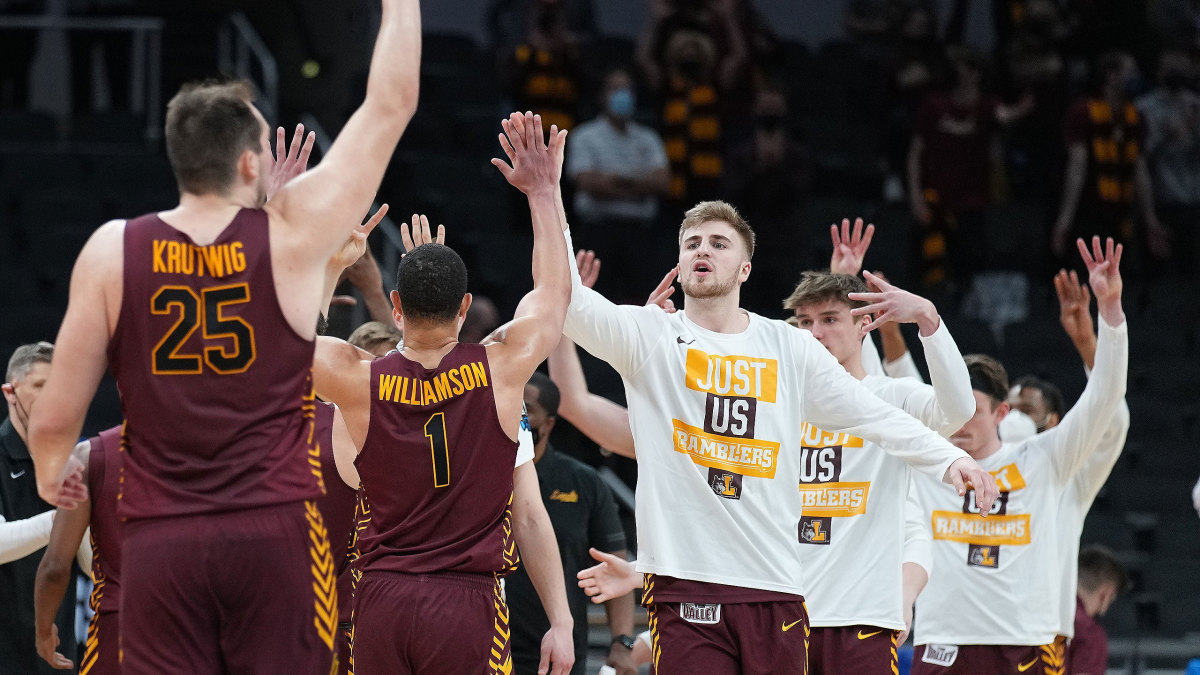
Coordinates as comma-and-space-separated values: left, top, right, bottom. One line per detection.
512, 461, 575, 675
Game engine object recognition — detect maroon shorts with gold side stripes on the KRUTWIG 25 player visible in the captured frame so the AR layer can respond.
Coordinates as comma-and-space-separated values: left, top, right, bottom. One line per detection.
120, 502, 337, 675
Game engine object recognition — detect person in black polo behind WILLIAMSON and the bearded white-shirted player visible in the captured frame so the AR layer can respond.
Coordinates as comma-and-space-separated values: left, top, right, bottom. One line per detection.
504, 372, 637, 675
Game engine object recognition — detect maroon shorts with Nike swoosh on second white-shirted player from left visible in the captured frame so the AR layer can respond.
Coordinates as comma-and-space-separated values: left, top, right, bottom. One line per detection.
809, 626, 900, 675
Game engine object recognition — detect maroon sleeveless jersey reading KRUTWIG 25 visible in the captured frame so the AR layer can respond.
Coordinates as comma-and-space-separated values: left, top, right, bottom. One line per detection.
108, 209, 322, 519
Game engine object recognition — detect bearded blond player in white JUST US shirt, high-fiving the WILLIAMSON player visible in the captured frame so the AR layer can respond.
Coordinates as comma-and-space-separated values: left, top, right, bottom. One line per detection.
563, 195, 995, 674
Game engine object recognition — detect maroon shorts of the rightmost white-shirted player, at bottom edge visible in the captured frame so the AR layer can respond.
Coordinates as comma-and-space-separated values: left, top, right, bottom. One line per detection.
912, 643, 1066, 675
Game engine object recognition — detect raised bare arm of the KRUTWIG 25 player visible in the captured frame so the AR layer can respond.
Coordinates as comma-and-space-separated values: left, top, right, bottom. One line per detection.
266, 0, 421, 262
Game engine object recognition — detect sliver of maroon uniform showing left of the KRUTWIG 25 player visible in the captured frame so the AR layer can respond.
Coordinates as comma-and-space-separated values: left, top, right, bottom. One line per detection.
79, 426, 121, 675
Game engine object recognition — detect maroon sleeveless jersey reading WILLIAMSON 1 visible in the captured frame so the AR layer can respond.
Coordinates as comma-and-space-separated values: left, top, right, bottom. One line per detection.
354, 344, 517, 574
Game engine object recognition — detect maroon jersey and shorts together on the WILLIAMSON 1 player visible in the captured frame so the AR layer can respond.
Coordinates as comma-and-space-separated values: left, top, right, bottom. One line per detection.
354, 344, 517, 675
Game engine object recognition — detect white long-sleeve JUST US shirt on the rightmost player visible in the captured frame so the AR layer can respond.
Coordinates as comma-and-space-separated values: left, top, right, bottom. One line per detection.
914, 321, 1129, 645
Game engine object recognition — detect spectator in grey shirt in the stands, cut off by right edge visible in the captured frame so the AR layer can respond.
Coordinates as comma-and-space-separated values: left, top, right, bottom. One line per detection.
1138, 52, 1200, 277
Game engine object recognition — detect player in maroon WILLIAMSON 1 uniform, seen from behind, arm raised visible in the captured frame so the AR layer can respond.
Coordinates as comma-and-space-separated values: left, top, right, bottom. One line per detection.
314, 113, 574, 674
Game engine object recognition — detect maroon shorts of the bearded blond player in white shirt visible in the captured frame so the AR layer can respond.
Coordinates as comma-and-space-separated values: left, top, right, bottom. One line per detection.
650, 601, 809, 675
